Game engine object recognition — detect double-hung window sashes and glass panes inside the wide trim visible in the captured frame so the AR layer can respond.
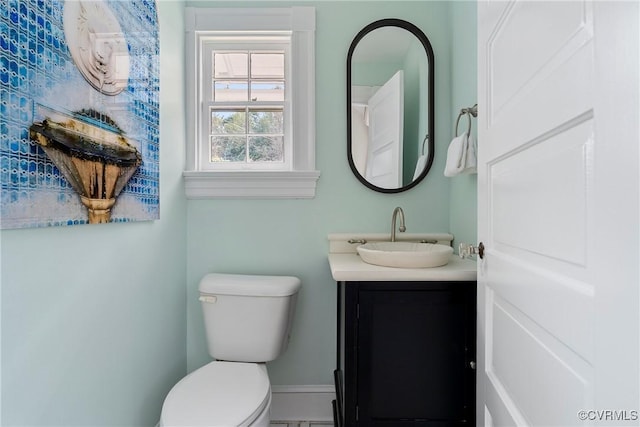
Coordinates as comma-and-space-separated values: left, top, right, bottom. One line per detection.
200, 41, 291, 170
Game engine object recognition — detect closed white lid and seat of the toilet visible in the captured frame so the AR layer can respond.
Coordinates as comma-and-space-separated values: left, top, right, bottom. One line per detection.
161, 362, 271, 426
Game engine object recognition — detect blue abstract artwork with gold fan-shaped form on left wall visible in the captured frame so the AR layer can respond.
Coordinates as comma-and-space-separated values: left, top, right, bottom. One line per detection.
0, 0, 159, 229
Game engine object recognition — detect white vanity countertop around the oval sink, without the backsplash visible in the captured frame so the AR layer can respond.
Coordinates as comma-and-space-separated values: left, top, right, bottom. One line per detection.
329, 253, 476, 282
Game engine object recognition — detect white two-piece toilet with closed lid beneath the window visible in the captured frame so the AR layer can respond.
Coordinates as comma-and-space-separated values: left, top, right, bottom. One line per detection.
159, 273, 301, 427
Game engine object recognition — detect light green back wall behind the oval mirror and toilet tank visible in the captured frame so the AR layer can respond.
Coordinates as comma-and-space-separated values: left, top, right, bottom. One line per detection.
187, 1, 451, 384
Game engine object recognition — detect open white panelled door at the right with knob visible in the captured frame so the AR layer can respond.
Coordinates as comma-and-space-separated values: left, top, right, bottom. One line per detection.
477, 0, 640, 426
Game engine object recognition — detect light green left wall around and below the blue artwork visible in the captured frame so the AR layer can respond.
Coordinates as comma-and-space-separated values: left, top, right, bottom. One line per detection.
0, 2, 186, 427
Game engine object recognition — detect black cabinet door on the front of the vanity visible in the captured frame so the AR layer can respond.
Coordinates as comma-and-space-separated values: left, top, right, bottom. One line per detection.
357, 283, 475, 426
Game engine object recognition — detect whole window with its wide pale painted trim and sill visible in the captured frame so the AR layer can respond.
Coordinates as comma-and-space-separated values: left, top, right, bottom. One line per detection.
184, 7, 319, 198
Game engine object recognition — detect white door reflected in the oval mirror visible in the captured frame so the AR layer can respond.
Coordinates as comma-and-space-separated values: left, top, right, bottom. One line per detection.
365, 70, 404, 188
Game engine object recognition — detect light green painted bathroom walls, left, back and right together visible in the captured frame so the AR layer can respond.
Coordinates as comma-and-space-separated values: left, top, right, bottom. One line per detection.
0, 0, 475, 426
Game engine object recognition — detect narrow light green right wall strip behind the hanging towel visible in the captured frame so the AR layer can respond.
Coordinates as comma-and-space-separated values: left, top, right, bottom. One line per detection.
449, 1, 482, 253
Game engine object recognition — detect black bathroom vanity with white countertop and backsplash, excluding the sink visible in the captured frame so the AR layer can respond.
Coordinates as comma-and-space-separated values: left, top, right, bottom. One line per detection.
329, 233, 476, 426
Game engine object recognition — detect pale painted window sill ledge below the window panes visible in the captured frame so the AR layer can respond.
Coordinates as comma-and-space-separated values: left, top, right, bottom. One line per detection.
182, 171, 320, 199
